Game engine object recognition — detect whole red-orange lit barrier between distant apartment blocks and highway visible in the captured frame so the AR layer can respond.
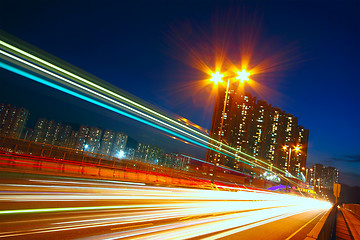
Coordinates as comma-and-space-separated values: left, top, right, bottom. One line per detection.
0, 136, 264, 188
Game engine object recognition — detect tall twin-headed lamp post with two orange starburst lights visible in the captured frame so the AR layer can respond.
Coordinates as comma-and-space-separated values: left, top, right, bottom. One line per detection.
210, 69, 250, 183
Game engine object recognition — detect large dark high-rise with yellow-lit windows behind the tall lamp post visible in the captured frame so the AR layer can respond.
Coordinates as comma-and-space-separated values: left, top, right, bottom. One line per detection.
206, 87, 308, 176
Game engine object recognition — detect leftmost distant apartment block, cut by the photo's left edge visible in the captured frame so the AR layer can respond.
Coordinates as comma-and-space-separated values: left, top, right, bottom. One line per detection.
0, 103, 29, 138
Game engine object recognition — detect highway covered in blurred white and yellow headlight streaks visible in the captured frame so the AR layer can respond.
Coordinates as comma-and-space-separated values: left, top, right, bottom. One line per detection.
0, 172, 331, 240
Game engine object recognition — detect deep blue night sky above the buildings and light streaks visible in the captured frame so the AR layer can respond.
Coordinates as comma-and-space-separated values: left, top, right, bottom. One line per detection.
0, 0, 360, 186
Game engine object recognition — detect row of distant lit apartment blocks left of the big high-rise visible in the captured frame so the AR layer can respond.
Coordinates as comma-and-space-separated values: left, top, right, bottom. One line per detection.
0, 102, 191, 166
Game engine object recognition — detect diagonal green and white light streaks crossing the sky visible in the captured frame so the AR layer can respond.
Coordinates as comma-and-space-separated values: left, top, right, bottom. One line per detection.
0, 40, 300, 184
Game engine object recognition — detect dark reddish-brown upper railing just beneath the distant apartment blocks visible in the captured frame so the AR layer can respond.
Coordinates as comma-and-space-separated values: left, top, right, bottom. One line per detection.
0, 136, 253, 187
